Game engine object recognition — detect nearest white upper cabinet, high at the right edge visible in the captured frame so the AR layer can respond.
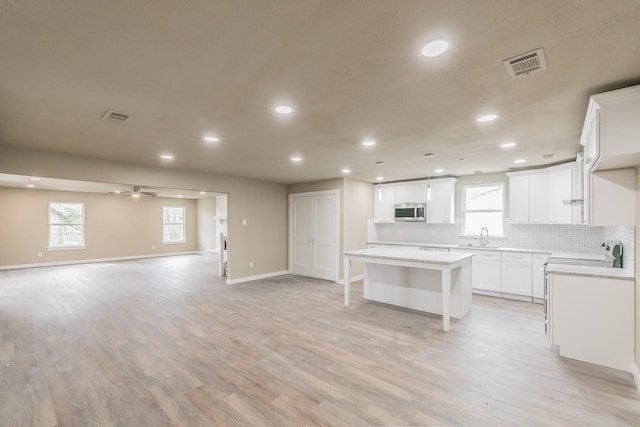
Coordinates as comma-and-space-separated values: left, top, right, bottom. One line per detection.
580, 85, 640, 171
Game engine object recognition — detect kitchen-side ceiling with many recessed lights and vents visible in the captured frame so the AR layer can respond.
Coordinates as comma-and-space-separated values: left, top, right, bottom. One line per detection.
0, 0, 640, 183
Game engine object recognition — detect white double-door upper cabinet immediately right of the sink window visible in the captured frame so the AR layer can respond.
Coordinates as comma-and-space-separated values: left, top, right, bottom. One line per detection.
507, 169, 549, 223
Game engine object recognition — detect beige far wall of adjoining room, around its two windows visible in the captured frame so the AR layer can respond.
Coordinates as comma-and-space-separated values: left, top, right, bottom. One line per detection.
0, 188, 198, 267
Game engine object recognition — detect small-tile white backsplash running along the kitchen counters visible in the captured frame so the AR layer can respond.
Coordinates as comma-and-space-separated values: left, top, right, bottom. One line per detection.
367, 219, 636, 274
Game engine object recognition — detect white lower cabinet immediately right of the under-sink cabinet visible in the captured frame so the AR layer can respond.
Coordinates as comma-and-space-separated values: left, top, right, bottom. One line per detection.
502, 252, 533, 301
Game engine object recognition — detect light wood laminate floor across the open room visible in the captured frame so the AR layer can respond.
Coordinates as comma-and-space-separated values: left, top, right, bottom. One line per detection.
0, 255, 640, 427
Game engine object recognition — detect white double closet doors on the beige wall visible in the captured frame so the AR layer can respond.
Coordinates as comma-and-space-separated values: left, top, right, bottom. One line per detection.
289, 192, 339, 281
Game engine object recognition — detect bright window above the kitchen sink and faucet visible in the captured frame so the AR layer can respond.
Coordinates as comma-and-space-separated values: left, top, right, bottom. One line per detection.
462, 184, 504, 237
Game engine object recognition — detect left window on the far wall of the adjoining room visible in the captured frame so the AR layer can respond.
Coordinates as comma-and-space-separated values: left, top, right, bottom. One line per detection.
47, 202, 85, 250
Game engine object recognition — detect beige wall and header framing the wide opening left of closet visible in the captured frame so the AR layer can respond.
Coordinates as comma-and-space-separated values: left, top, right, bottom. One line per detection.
0, 145, 288, 280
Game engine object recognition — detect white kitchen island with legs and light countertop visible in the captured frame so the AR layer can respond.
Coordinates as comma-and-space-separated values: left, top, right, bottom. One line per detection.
344, 248, 473, 331
